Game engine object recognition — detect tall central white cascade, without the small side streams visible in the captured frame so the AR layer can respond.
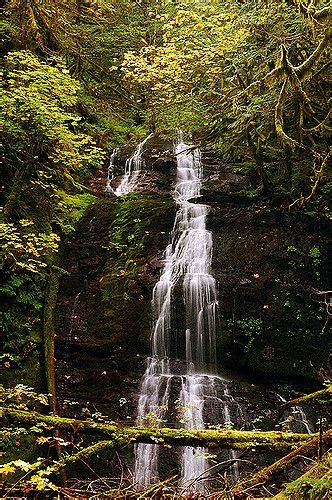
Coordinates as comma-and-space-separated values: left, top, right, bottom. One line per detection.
135, 136, 219, 493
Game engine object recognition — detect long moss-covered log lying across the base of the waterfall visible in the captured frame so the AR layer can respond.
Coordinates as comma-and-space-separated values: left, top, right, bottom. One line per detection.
0, 408, 320, 450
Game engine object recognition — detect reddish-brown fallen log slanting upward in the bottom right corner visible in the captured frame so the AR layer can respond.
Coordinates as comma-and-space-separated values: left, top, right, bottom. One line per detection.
232, 430, 332, 498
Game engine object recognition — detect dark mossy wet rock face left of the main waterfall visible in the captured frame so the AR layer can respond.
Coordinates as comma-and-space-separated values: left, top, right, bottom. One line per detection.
56, 193, 175, 418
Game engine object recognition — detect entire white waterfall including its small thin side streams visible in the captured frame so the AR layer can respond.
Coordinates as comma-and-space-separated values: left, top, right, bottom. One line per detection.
111, 134, 311, 494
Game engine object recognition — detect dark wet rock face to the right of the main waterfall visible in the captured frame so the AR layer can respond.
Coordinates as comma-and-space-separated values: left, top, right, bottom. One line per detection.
203, 150, 328, 379
